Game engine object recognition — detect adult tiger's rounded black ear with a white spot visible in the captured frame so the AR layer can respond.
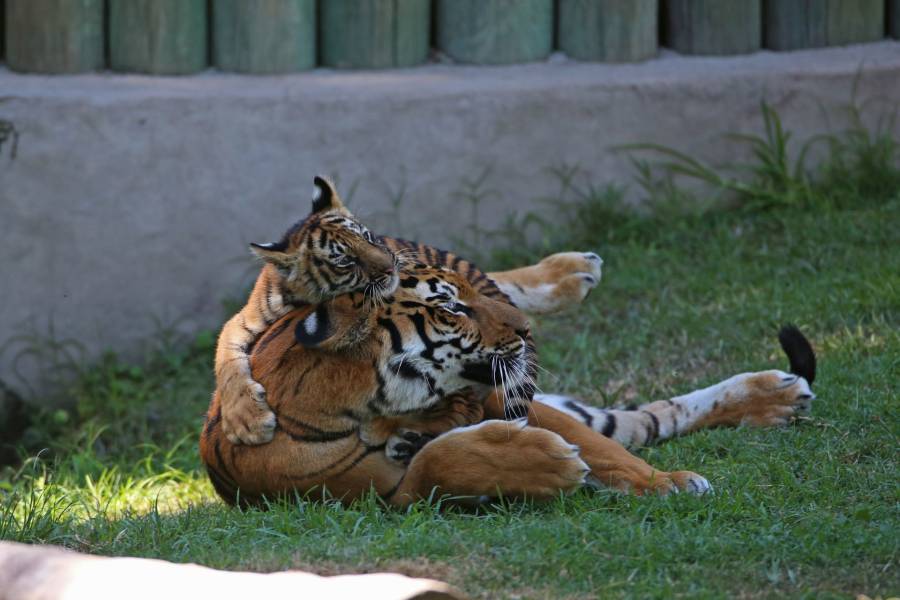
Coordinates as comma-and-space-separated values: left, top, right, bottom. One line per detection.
294, 294, 373, 351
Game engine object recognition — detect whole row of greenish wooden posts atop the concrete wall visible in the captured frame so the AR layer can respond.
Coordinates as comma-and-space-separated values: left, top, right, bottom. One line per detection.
0, 0, 900, 75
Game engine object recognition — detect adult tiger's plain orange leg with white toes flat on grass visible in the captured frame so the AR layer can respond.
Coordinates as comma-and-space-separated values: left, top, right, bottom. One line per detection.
485, 394, 710, 495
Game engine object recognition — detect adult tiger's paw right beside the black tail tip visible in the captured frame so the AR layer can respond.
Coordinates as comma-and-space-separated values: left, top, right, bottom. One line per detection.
705, 370, 816, 427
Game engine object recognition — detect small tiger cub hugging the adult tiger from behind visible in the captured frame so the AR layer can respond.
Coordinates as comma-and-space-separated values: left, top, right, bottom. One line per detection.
214, 176, 603, 445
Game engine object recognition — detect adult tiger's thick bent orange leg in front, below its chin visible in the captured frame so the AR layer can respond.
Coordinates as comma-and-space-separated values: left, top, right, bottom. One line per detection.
388, 420, 589, 506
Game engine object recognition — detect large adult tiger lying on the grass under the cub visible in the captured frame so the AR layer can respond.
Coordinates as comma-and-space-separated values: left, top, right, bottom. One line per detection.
200, 263, 814, 507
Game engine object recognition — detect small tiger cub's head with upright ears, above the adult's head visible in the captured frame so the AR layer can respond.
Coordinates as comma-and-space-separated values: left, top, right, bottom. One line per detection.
250, 177, 399, 303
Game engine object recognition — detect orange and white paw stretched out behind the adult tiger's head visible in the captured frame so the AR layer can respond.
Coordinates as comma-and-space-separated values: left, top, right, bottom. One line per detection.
488, 252, 603, 315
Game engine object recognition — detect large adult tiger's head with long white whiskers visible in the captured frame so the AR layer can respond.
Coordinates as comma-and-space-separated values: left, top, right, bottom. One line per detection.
278, 263, 534, 415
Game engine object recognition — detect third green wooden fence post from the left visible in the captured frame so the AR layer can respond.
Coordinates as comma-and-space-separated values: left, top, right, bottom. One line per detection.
212, 0, 316, 74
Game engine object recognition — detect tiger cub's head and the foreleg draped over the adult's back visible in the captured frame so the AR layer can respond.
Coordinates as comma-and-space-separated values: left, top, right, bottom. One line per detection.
215, 177, 399, 444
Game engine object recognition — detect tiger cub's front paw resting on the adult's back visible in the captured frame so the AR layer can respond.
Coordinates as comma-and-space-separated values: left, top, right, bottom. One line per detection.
222, 379, 277, 446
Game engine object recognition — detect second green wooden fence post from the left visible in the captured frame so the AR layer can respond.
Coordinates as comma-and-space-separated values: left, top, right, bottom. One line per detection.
109, 0, 207, 75
